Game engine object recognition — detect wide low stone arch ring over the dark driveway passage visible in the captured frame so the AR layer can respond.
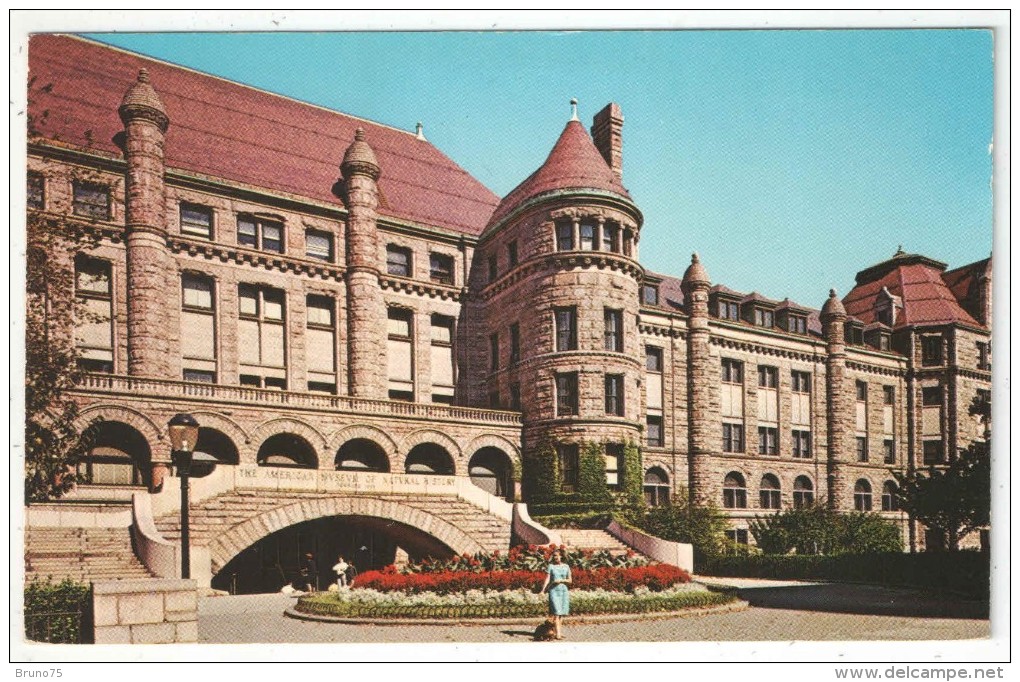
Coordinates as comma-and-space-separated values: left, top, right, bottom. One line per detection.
209, 497, 485, 574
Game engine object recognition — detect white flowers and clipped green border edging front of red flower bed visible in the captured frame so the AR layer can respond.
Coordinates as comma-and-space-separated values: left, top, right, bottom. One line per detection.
295, 583, 736, 619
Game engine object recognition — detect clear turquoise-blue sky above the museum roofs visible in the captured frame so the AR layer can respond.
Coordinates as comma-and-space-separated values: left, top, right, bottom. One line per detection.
83, 30, 993, 299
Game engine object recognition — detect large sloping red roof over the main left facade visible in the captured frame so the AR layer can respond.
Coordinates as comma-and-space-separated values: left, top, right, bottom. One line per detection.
29, 36, 499, 234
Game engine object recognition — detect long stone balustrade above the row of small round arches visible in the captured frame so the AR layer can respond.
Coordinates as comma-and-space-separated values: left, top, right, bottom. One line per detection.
75, 374, 521, 427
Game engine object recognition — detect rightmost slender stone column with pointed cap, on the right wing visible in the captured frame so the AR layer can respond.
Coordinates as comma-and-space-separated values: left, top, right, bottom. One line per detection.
821, 290, 854, 510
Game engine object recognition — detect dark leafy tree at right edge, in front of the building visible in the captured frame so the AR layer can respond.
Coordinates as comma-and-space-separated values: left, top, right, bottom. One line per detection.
893, 395, 991, 552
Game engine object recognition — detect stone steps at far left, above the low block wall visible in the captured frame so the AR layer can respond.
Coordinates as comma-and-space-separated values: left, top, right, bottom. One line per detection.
24, 527, 153, 583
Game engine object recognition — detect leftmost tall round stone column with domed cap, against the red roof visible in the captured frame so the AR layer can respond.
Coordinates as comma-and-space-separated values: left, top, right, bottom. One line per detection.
118, 68, 173, 379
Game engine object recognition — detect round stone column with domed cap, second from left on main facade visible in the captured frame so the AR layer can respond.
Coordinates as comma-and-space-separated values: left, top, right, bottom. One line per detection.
340, 127, 387, 399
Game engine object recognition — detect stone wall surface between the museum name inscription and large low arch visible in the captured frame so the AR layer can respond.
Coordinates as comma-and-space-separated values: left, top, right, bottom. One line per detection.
156, 490, 510, 552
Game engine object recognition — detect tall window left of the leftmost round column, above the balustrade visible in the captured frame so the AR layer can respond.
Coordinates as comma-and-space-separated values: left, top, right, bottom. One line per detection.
74, 256, 113, 372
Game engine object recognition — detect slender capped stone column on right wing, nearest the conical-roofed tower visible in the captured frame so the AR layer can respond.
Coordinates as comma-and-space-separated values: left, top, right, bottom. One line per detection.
681, 254, 719, 505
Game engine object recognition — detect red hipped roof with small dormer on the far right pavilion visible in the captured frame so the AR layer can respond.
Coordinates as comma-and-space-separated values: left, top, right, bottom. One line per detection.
843, 254, 982, 328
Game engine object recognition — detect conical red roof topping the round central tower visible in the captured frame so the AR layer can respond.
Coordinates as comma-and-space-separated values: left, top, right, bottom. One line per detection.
490, 120, 630, 224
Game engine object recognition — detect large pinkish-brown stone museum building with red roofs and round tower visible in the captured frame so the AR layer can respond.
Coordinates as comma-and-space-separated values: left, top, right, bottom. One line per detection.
28, 36, 991, 584
